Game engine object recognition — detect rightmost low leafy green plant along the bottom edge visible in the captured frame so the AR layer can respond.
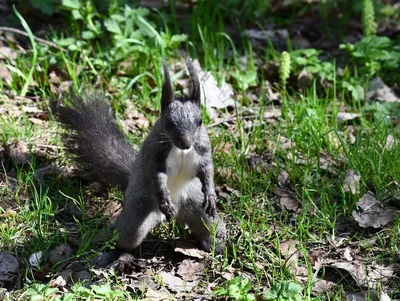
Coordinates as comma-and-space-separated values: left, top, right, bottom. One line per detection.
264, 281, 304, 301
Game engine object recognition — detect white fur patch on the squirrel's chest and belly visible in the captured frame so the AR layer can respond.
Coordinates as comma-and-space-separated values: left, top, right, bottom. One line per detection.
167, 146, 199, 201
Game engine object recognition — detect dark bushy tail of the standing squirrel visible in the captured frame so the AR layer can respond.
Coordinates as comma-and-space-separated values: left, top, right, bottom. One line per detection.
52, 94, 136, 189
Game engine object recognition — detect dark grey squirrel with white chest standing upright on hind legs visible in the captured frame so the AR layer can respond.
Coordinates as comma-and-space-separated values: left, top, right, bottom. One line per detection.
52, 57, 227, 252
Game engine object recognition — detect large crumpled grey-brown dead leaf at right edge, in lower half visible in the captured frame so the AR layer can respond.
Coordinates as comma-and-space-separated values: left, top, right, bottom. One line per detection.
352, 193, 394, 228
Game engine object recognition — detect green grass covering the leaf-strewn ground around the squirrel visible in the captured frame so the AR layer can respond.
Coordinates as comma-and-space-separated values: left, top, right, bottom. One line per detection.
0, 1, 400, 300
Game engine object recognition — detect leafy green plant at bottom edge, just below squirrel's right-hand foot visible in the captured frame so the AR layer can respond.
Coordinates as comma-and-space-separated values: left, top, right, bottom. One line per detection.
214, 277, 256, 301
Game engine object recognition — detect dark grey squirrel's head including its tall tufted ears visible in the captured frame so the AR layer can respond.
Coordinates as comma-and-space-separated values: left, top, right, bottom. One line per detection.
161, 58, 202, 149
